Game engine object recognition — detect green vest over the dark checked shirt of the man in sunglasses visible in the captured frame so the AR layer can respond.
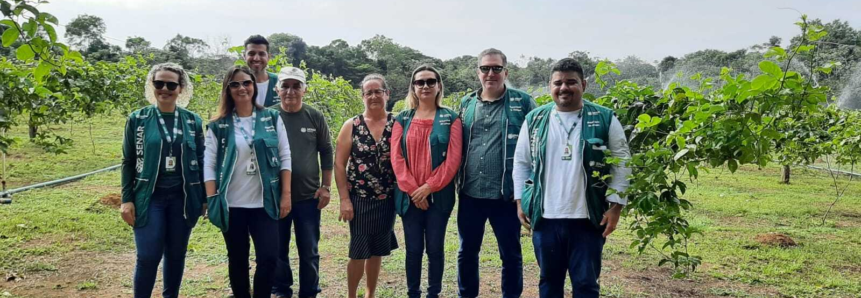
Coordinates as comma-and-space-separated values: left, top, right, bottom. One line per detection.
457, 88, 535, 200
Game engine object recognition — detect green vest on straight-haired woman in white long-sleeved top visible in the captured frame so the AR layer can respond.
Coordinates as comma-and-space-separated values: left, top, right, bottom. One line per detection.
207, 109, 281, 231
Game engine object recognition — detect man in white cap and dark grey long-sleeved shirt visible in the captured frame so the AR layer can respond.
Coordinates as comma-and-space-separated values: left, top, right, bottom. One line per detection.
272, 67, 333, 298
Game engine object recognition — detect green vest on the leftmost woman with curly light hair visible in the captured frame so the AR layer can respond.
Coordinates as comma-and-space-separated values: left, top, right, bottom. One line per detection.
122, 105, 206, 227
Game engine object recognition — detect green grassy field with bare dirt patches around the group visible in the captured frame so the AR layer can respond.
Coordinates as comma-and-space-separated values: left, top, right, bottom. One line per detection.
0, 116, 861, 297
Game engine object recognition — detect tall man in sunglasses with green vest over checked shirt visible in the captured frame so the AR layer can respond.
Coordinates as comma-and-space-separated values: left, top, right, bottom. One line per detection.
457, 48, 535, 298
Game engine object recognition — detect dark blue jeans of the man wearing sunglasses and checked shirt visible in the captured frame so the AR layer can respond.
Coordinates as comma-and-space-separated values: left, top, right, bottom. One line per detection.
457, 196, 523, 298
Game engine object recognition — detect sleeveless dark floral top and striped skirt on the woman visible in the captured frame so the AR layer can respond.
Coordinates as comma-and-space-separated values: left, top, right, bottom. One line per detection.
347, 114, 398, 260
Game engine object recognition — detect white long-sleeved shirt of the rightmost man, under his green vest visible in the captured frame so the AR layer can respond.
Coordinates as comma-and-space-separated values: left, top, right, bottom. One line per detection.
512, 110, 631, 218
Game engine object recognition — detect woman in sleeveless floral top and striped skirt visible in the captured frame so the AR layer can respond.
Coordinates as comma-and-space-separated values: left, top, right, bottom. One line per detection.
335, 74, 398, 298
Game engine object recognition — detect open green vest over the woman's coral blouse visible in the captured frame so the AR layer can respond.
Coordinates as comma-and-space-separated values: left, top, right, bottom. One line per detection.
395, 107, 457, 216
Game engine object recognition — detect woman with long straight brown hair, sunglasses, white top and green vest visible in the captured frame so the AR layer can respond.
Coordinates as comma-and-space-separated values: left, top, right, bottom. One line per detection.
204, 66, 291, 298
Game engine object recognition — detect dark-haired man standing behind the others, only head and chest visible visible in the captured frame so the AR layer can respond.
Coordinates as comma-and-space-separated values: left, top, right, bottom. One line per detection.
243, 35, 278, 107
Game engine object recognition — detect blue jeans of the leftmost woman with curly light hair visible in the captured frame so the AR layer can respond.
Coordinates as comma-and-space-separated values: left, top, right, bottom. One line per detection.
134, 187, 191, 298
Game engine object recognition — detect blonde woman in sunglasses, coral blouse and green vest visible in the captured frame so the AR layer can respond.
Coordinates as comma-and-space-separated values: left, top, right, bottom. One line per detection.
391, 65, 462, 297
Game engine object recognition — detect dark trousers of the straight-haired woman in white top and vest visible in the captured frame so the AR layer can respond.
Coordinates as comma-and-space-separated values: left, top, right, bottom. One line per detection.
222, 208, 278, 298
